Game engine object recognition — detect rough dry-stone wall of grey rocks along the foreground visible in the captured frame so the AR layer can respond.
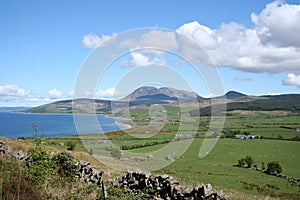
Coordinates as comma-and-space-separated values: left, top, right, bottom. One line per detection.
0, 141, 229, 200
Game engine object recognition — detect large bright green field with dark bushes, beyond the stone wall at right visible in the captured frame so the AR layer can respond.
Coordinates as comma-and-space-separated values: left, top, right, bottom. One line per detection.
161, 139, 300, 197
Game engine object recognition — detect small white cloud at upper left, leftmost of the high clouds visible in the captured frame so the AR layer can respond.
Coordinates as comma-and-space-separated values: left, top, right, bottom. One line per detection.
81, 33, 116, 48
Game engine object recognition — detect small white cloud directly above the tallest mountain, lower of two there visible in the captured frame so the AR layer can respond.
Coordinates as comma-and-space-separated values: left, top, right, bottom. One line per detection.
122, 51, 166, 67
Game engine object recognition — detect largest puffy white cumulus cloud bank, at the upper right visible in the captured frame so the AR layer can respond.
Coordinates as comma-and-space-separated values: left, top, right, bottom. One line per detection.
176, 1, 300, 73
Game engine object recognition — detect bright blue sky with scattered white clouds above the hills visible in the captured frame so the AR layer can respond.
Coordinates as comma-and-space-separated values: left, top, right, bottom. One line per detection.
0, 0, 300, 106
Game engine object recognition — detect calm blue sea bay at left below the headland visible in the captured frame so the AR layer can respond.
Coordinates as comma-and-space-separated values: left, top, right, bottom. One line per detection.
0, 112, 127, 138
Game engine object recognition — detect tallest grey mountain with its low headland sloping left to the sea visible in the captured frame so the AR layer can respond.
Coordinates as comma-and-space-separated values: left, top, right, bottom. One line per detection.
26, 86, 202, 113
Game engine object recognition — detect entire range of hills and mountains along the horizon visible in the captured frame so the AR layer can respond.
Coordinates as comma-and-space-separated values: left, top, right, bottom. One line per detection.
26, 87, 300, 115
